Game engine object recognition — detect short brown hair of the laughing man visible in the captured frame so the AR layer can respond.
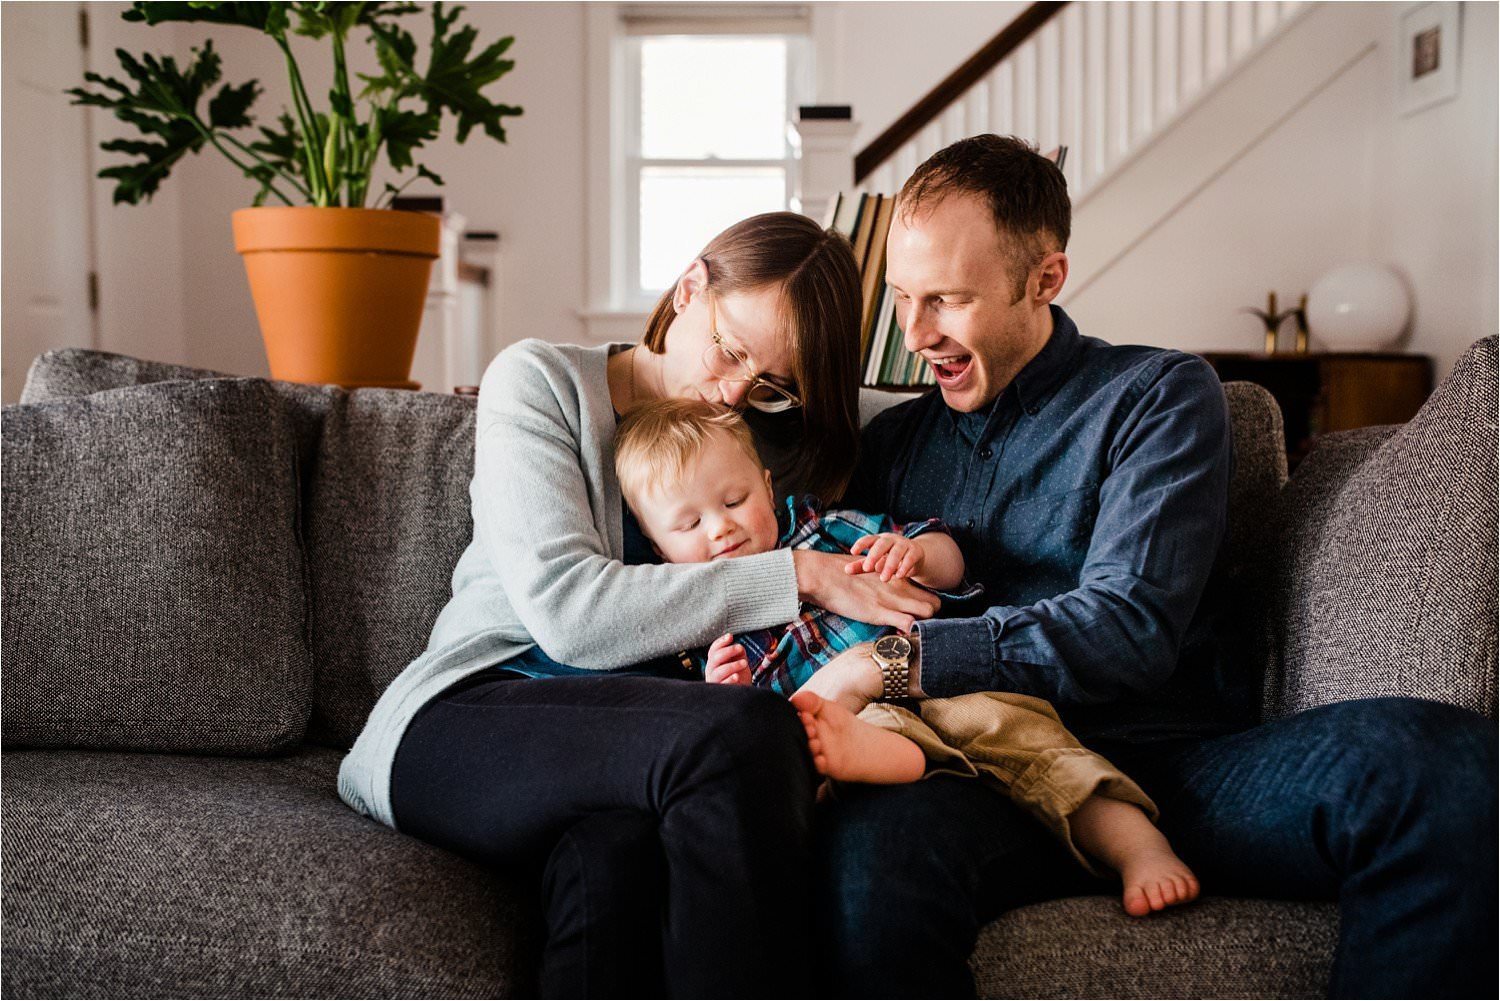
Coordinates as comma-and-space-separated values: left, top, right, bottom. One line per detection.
897, 134, 1073, 299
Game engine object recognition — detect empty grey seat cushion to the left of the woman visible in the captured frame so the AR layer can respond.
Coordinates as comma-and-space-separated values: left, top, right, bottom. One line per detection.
0, 747, 537, 998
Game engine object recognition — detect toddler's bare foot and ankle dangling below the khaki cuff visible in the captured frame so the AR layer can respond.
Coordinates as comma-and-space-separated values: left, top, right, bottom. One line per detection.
1073, 795, 1199, 917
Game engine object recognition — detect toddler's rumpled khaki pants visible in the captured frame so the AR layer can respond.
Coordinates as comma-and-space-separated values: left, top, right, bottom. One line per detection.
860, 692, 1158, 875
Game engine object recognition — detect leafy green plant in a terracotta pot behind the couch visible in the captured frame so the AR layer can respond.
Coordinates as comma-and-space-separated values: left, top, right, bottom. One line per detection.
68, 2, 521, 389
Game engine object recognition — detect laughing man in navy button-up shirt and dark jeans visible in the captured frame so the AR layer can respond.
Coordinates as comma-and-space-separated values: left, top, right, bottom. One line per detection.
818, 135, 1497, 996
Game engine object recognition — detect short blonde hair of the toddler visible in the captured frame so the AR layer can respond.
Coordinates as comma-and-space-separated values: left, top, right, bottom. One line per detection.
615, 399, 765, 515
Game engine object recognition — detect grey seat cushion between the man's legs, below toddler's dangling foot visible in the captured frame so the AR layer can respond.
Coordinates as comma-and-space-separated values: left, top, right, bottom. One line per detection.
969, 897, 1338, 998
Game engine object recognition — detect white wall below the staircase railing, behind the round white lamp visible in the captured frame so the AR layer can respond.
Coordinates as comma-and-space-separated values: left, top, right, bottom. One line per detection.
1064, 3, 1500, 378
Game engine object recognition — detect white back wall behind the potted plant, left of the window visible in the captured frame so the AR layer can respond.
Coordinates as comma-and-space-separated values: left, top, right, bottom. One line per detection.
156, 3, 584, 374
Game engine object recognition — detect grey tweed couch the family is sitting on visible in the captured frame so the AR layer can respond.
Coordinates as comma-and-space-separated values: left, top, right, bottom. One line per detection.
0, 338, 1497, 998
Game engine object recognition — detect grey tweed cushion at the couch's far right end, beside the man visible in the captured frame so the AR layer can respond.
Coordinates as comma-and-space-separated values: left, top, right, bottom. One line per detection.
1266, 336, 1497, 717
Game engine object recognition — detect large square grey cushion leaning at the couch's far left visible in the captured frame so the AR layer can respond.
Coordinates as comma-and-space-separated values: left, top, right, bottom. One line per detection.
0, 380, 312, 753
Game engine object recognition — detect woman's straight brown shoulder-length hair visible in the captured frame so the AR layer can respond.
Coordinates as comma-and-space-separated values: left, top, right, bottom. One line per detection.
642, 212, 861, 503
